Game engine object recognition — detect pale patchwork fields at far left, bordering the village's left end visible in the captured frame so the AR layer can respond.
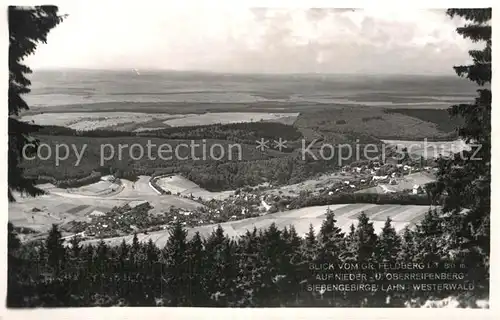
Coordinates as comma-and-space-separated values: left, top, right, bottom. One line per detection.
9, 176, 201, 240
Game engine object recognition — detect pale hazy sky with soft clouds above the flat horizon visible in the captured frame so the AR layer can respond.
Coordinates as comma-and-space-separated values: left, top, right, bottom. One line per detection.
27, 5, 478, 74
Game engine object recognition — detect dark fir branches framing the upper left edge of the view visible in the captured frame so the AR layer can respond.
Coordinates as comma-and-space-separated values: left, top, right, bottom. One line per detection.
8, 6, 64, 201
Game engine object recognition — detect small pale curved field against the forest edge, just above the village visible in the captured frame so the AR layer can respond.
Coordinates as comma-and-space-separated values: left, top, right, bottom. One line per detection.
156, 175, 234, 200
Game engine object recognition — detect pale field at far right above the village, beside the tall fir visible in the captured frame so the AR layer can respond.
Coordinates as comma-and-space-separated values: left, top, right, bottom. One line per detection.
382, 140, 470, 159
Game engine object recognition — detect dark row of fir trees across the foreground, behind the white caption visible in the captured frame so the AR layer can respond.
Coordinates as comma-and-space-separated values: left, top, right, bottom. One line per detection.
7, 210, 489, 307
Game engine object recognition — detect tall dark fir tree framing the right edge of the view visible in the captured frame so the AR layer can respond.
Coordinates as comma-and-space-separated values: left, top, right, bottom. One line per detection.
437, 8, 492, 263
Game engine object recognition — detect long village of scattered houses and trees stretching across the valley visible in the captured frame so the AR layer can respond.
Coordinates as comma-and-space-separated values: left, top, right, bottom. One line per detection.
52, 151, 436, 240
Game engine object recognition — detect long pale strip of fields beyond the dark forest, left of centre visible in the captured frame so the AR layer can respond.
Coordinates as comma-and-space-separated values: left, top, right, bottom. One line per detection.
21, 112, 298, 131
